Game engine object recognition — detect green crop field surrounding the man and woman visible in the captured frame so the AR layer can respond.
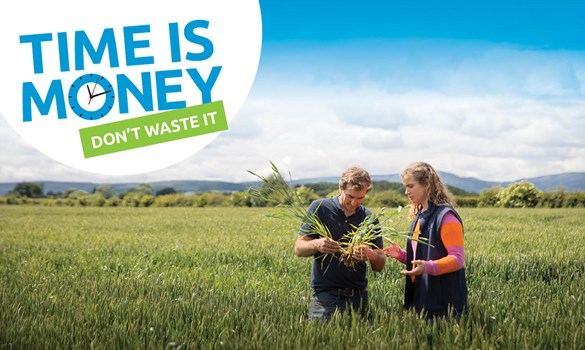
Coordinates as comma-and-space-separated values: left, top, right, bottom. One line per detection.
0, 205, 585, 349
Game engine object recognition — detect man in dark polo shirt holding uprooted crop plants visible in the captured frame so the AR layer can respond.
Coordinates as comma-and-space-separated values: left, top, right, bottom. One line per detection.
295, 167, 386, 319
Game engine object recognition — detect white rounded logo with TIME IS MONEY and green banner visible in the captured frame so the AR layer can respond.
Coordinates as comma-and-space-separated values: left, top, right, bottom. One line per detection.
0, 0, 262, 175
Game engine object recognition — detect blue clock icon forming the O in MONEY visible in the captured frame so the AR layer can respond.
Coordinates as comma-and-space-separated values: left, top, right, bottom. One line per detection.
69, 73, 116, 120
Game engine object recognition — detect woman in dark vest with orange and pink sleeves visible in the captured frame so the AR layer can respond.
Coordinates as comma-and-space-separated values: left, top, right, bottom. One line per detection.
384, 162, 467, 318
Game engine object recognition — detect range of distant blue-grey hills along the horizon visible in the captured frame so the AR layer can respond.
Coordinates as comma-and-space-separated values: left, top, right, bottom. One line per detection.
0, 172, 585, 195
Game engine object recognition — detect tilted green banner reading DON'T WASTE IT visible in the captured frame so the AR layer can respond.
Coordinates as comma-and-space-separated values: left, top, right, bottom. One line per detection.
79, 101, 228, 158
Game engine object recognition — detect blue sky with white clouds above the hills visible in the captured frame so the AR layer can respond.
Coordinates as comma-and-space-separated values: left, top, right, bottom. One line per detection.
0, 0, 585, 183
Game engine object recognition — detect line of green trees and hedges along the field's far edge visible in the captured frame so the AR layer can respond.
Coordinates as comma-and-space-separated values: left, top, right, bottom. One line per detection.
0, 181, 585, 208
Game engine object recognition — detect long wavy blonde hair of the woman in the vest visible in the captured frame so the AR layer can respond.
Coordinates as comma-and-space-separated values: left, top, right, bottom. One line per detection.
400, 162, 456, 220
